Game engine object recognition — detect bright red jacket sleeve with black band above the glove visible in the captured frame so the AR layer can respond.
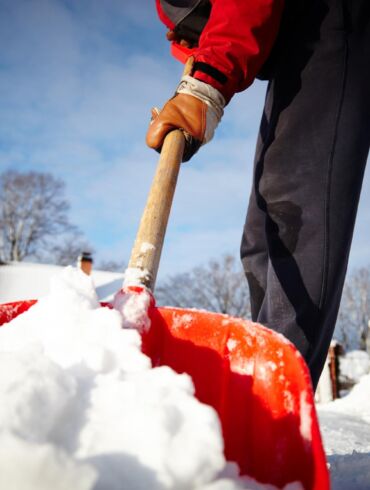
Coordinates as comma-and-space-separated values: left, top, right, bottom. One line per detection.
193, 0, 284, 102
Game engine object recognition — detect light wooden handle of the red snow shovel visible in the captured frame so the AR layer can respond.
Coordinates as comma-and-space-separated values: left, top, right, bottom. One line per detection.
128, 58, 193, 291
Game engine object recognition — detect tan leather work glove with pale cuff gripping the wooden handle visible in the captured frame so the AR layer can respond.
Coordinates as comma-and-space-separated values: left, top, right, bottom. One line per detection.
146, 75, 225, 162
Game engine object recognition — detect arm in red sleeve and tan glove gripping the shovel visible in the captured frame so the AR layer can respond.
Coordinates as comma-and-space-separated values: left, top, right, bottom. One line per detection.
146, 0, 284, 160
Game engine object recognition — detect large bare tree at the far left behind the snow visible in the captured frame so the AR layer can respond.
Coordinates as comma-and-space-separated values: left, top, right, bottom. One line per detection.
0, 170, 87, 261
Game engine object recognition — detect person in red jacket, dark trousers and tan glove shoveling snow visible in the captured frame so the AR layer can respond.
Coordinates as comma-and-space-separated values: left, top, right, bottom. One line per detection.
147, 0, 370, 387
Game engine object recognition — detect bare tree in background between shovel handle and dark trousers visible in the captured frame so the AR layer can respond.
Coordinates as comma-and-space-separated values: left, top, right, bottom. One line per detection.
155, 255, 250, 317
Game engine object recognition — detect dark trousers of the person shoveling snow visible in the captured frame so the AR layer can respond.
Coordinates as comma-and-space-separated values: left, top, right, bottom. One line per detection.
241, 0, 370, 387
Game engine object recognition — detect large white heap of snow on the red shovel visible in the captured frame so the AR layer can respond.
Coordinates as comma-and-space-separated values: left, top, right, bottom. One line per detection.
0, 268, 301, 490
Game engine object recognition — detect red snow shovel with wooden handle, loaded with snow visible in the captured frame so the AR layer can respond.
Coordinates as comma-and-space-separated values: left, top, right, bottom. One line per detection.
0, 52, 330, 490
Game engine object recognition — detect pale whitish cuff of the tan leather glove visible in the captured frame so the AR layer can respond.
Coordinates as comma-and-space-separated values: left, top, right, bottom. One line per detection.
176, 75, 226, 120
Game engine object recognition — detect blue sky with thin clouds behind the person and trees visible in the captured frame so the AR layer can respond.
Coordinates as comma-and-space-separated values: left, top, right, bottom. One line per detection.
0, 0, 370, 279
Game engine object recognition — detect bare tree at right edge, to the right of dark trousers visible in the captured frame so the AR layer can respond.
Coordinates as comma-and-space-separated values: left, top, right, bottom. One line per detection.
335, 266, 370, 350
